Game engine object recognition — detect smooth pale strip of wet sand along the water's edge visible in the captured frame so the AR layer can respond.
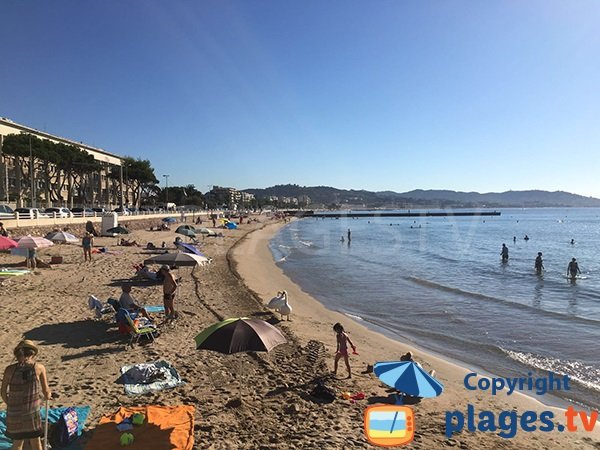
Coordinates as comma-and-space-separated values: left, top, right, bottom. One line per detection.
231, 219, 600, 448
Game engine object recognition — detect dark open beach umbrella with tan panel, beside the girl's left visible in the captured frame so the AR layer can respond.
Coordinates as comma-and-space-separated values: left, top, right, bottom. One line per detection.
194, 317, 287, 354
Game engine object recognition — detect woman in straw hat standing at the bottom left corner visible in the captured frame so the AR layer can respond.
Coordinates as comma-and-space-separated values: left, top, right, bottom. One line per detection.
1, 340, 50, 450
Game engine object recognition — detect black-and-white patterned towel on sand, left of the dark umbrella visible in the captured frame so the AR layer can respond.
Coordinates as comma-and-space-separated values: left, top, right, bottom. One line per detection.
120, 360, 184, 395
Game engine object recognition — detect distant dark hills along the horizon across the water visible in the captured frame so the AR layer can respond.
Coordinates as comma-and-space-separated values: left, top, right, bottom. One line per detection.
244, 184, 600, 209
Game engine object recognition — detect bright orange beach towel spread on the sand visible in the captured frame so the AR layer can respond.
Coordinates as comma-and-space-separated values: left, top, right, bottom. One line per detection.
85, 405, 194, 450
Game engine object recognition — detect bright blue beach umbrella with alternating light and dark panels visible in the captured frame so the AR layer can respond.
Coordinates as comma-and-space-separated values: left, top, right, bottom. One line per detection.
373, 361, 444, 398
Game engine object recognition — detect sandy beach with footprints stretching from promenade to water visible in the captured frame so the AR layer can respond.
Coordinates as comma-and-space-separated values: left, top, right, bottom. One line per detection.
0, 216, 600, 449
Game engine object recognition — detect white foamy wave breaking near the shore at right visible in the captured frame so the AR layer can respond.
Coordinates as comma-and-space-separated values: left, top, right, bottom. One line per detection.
501, 348, 600, 392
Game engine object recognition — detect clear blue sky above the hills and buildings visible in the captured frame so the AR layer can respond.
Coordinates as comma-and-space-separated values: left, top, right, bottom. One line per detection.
0, 0, 600, 197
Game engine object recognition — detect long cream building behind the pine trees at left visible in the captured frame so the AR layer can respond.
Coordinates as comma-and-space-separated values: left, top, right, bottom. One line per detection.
0, 118, 127, 207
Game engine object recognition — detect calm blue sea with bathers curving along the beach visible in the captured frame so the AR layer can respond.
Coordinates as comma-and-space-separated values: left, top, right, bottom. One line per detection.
270, 208, 600, 410
